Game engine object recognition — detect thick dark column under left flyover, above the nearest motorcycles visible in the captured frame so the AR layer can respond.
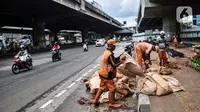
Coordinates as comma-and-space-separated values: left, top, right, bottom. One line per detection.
33, 19, 45, 48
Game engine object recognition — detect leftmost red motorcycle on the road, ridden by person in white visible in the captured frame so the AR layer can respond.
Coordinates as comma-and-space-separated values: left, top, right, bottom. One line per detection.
12, 54, 33, 74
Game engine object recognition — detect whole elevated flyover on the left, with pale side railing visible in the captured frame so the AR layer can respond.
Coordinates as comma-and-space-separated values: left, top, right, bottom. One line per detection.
0, 0, 122, 45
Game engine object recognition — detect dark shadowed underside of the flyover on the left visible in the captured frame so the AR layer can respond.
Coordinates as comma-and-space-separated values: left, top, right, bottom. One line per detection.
0, 0, 119, 32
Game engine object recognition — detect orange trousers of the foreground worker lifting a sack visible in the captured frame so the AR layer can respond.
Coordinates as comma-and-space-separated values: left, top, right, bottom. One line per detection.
100, 77, 116, 92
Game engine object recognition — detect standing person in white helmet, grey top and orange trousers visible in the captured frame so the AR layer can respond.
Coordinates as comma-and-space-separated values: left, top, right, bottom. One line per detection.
156, 31, 167, 66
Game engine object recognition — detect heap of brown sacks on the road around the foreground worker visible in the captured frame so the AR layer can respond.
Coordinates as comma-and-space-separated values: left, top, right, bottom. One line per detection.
87, 52, 144, 102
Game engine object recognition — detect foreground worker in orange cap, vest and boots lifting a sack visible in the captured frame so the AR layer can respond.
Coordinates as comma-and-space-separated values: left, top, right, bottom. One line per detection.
93, 39, 126, 108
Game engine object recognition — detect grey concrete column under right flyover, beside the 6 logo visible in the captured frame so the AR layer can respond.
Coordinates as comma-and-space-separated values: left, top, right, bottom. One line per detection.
163, 15, 177, 39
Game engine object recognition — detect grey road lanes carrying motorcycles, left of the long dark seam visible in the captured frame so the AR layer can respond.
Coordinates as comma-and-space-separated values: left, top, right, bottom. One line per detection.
0, 46, 105, 112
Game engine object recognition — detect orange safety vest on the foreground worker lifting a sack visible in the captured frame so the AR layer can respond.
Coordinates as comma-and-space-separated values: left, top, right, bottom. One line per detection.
99, 50, 116, 79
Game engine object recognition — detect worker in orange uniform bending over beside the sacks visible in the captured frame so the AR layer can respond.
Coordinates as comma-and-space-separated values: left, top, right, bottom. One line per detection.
136, 42, 158, 71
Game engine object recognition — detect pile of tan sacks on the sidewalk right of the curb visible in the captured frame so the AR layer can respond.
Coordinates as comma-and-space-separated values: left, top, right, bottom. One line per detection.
137, 67, 185, 96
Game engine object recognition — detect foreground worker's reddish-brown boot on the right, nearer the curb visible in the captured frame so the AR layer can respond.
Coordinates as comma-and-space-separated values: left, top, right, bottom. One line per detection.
108, 92, 122, 108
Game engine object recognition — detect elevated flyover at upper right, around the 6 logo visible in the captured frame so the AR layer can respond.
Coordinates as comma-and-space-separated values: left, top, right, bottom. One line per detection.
137, 0, 200, 36
